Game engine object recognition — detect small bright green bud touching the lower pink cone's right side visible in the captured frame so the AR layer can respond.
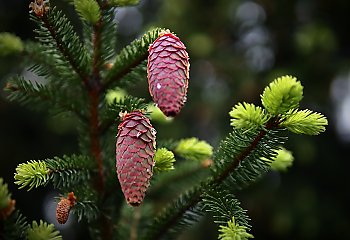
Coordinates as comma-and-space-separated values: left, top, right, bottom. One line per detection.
154, 148, 175, 173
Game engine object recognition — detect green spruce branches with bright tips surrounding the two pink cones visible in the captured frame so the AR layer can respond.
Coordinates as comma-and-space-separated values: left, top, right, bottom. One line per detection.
0, 0, 328, 240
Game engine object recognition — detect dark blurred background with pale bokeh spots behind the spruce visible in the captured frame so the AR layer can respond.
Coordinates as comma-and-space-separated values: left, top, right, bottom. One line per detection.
0, 0, 350, 240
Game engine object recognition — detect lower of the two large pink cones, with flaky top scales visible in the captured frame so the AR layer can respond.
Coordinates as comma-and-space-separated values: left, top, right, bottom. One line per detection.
116, 111, 156, 206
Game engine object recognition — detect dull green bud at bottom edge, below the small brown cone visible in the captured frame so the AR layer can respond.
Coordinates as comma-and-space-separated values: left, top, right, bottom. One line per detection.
27, 220, 62, 240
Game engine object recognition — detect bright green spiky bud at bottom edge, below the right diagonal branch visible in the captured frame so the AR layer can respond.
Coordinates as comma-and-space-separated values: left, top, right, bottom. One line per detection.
219, 217, 254, 240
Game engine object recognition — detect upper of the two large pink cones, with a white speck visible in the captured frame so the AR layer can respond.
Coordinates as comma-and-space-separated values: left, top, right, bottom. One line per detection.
147, 32, 190, 117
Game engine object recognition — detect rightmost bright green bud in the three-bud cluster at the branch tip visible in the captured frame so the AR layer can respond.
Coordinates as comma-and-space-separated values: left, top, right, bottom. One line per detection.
280, 109, 328, 135
